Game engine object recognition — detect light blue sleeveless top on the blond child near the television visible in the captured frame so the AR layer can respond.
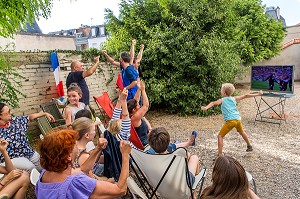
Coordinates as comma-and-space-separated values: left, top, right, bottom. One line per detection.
221, 96, 241, 121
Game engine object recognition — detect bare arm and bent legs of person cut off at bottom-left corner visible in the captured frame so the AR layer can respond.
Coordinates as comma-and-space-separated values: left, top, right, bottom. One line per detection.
0, 138, 30, 198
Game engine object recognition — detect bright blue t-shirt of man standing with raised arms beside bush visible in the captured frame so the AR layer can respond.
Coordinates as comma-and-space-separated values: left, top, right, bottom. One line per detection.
123, 65, 139, 101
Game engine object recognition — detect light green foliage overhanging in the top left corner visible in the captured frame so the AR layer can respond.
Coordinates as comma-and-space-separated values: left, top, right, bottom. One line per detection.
0, 0, 52, 37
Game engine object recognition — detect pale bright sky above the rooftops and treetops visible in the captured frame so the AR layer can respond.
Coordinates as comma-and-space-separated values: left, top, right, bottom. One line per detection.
38, 0, 300, 34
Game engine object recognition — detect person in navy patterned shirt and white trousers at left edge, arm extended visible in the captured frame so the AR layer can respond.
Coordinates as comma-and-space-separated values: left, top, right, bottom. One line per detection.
0, 102, 54, 171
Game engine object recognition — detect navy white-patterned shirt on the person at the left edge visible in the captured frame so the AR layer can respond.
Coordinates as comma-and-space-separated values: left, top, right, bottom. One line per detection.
0, 116, 34, 163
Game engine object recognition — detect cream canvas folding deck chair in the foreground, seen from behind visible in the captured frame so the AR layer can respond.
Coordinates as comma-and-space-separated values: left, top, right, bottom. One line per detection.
130, 148, 206, 199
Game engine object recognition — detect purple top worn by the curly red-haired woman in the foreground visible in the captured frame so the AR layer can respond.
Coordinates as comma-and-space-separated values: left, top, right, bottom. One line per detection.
35, 170, 97, 199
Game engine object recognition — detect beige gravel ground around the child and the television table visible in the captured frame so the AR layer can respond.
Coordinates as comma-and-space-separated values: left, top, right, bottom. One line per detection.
147, 82, 300, 199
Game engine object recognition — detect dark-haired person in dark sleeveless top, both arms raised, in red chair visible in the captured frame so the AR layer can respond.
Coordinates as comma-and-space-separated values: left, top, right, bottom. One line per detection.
127, 81, 151, 146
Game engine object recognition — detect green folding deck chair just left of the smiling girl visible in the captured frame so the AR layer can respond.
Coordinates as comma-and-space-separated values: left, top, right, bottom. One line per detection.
40, 101, 66, 128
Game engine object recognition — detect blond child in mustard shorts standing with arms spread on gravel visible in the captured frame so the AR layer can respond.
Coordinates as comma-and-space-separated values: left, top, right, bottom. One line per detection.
201, 83, 263, 155
